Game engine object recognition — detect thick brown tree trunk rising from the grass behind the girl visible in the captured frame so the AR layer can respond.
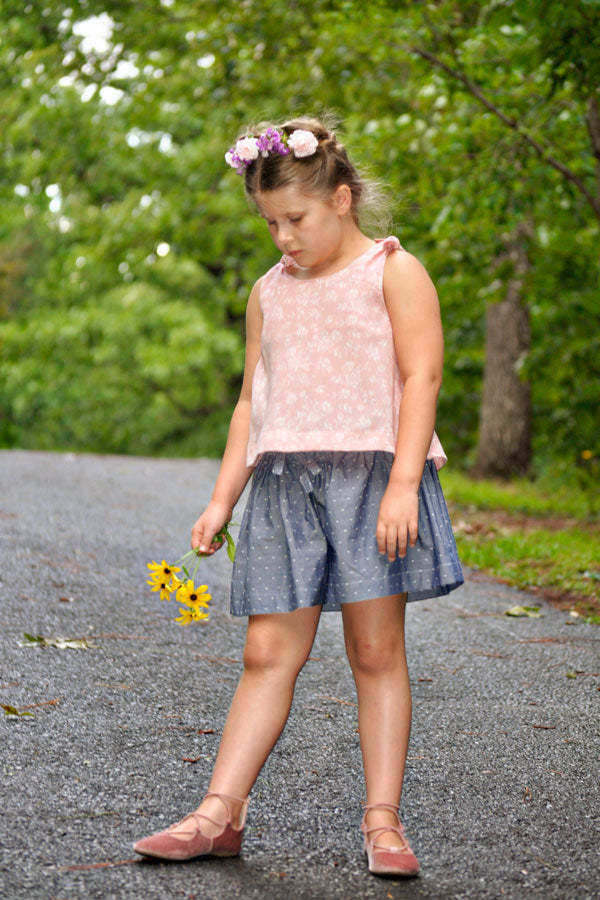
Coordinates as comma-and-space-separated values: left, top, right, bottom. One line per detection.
471, 225, 531, 479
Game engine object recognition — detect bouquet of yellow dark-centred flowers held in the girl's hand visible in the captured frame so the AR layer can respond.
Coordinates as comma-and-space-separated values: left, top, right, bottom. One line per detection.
146, 522, 236, 625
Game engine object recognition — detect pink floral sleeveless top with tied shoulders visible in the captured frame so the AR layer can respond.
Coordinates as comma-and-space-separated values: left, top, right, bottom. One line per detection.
246, 237, 448, 469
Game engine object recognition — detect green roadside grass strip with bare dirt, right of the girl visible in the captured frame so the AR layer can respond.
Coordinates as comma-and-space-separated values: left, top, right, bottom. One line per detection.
440, 469, 600, 624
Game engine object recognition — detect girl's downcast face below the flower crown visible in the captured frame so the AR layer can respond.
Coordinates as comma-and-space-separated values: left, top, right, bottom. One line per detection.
255, 184, 351, 269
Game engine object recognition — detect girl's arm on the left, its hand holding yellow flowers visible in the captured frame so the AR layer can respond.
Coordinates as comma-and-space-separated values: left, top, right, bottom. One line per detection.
191, 278, 262, 554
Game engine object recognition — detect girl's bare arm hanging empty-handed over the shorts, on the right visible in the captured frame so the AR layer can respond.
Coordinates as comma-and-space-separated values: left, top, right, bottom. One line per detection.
377, 251, 444, 559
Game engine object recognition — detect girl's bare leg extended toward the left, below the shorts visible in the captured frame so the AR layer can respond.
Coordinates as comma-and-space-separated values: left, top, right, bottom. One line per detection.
169, 606, 321, 837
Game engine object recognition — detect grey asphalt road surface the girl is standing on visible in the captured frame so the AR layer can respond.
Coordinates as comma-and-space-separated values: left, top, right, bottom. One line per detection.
0, 451, 600, 900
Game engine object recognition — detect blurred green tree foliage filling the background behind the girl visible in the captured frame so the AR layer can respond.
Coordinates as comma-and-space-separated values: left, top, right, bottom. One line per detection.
0, 0, 600, 482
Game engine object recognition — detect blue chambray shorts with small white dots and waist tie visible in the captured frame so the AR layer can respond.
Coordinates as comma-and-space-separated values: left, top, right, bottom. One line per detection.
230, 450, 464, 616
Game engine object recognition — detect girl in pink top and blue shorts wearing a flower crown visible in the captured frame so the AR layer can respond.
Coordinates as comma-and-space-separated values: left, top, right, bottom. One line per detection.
134, 118, 464, 876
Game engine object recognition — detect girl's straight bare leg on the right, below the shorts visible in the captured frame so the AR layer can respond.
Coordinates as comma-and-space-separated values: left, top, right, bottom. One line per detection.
342, 594, 412, 847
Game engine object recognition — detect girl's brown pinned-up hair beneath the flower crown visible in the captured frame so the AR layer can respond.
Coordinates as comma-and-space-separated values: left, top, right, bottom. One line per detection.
238, 113, 392, 234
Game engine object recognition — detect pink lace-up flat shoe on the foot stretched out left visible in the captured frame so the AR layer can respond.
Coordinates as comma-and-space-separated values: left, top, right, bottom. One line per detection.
133, 791, 250, 861
